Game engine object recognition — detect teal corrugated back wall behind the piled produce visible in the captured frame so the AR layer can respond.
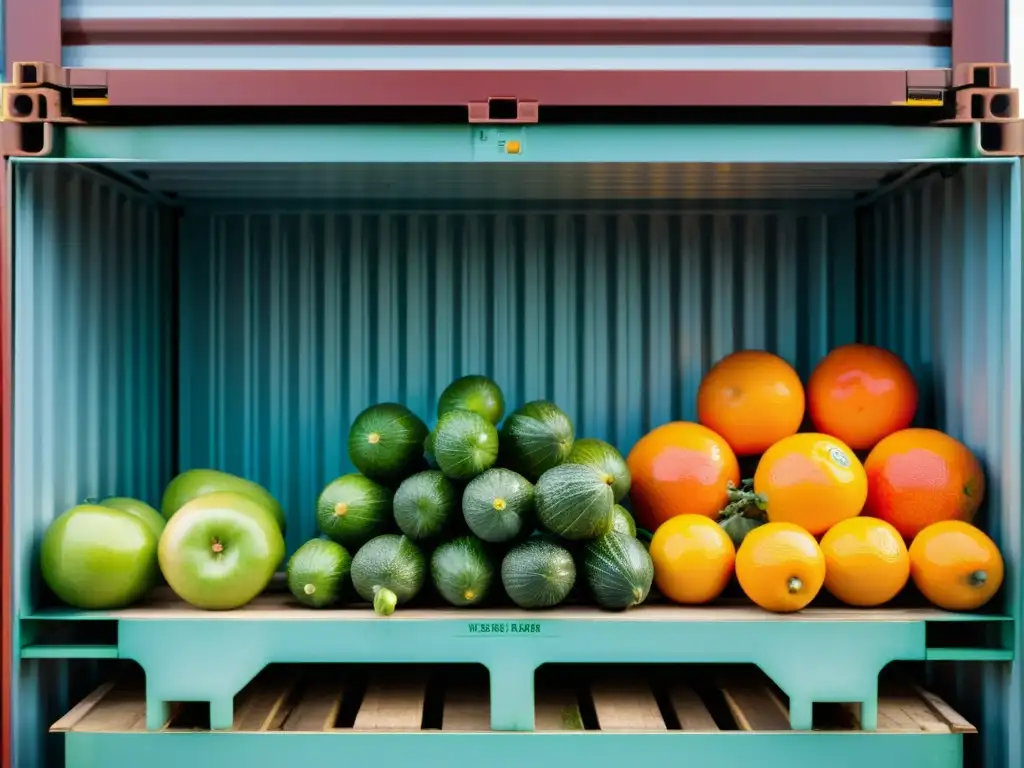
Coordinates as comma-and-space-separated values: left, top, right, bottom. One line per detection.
179, 211, 856, 549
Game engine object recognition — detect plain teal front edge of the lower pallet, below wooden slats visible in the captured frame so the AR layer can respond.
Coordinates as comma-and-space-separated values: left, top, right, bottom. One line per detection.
65, 732, 964, 768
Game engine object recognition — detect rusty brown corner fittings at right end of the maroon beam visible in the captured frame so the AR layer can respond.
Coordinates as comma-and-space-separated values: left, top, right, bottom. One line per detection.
936, 61, 1024, 157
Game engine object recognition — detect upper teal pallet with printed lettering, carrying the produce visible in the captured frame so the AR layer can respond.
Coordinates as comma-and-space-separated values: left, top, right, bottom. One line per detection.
28, 594, 1011, 731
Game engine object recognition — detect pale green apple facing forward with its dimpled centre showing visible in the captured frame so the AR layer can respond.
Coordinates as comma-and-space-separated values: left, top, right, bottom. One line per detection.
158, 490, 285, 610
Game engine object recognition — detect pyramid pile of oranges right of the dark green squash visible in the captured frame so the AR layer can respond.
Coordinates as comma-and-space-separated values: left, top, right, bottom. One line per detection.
643, 344, 1004, 611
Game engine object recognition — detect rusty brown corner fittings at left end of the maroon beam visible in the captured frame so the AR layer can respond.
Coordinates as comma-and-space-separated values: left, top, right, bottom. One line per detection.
0, 61, 106, 157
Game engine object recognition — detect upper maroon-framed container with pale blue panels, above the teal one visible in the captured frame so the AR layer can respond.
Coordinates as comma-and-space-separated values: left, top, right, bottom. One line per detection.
4, 0, 1009, 112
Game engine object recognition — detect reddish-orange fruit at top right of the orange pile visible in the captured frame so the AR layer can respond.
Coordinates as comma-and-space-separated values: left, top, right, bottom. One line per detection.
807, 344, 918, 451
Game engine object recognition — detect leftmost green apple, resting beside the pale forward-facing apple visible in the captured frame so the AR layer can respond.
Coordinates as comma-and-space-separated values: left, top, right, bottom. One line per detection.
41, 504, 158, 609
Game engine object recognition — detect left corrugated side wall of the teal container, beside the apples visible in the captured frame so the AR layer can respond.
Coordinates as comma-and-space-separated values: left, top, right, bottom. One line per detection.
12, 164, 174, 766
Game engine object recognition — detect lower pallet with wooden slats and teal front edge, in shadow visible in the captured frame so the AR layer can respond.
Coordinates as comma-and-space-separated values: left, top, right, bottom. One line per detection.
51, 665, 975, 768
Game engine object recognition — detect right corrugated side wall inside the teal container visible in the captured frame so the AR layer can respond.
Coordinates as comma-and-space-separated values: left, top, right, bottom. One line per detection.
859, 165, 1024, 768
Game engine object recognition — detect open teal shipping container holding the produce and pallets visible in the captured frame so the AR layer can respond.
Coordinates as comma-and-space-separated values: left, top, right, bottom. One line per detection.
0, 121, 1024, 768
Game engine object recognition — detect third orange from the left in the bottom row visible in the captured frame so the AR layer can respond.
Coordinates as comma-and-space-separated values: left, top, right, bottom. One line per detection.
820, 517, 910, 608
